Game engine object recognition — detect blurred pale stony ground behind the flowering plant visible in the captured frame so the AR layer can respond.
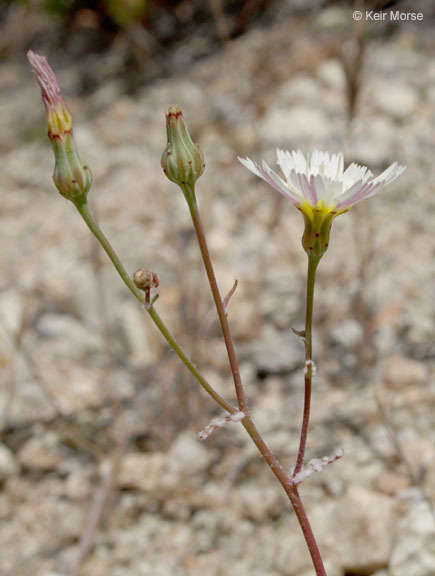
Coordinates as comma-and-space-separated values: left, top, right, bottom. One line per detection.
0, 0, 435, 576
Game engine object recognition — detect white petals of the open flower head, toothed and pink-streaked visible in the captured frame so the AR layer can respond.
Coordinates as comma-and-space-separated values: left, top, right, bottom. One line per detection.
239, 149, 405, 214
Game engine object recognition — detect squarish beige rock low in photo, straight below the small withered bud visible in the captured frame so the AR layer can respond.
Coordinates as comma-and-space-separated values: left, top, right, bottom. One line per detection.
116, 452, 166, 492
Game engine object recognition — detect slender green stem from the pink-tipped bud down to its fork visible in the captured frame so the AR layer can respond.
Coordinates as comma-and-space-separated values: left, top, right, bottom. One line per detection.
75, 202, 237, 414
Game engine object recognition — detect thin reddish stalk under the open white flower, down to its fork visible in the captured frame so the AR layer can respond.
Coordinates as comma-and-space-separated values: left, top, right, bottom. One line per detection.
293, 254, 319, 476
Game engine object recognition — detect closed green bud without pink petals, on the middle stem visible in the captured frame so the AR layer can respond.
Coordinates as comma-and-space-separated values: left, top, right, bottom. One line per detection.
162, 106, 205, 186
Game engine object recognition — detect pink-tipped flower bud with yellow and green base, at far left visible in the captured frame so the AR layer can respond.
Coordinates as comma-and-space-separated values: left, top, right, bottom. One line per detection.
27, 50, 92, 203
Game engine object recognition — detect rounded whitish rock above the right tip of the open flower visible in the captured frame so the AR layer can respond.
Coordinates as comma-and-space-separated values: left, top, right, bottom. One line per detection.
372, 80, 419, 120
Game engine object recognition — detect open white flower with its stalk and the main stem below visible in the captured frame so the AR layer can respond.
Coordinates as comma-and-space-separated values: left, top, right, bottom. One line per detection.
239, 150, 405, 576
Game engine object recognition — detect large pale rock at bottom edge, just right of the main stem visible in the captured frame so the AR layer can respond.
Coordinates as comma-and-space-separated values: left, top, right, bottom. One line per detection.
312, 487, 395, 574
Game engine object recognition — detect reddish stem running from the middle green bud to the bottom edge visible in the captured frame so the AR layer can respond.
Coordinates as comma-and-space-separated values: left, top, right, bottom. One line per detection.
183, 187, 326, 576
